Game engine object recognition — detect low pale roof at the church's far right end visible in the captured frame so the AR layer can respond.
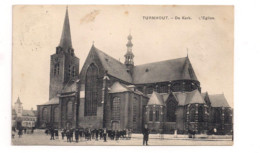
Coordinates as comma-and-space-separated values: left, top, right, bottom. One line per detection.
209, 94, 230, 107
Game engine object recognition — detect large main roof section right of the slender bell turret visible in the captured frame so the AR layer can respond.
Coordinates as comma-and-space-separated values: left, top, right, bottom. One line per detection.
133, 57, 197, 84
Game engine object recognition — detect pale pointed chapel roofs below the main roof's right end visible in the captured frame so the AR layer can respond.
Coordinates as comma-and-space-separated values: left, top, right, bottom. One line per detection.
173, 89, 205, 106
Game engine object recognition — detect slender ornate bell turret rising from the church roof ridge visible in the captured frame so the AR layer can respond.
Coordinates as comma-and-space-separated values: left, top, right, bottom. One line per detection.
125, 34, 134, 74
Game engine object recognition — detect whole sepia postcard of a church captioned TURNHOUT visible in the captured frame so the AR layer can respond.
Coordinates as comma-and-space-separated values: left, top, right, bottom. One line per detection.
10, 5, 235, 146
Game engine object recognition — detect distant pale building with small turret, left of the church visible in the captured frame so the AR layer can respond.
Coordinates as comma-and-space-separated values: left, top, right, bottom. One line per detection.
12, 97, 37, 128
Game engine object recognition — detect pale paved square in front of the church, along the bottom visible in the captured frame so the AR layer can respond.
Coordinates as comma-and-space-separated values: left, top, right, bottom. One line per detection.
12, 131, 233, 146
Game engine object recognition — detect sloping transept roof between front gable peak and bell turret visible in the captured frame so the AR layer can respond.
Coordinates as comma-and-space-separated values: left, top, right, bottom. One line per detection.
91, 45, 132, 82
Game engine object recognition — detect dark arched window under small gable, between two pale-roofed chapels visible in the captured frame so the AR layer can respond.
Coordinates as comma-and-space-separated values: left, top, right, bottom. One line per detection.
166, 100, 177, 122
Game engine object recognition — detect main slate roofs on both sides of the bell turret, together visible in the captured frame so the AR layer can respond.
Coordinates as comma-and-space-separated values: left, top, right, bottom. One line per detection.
91, 45, 197, 84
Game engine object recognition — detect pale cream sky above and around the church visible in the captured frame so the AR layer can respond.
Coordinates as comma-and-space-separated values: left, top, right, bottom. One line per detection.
12, 5, 234, 109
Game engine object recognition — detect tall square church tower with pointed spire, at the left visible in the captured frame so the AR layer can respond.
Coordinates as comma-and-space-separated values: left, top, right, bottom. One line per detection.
49, 8, 79, 99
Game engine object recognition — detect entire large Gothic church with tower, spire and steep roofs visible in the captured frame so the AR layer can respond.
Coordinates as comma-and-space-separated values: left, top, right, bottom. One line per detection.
37, 9, 233, 134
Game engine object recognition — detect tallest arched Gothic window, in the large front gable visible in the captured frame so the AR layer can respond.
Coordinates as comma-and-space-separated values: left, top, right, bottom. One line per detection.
85, 64, 98, 116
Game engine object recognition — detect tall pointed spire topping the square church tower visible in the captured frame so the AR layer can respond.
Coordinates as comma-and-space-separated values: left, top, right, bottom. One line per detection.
59, 6, 72, 52
